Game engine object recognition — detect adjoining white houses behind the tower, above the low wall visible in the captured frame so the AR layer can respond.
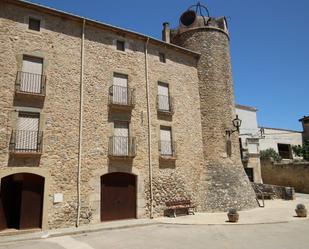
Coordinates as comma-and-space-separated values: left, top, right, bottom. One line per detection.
236, 105, 303, 183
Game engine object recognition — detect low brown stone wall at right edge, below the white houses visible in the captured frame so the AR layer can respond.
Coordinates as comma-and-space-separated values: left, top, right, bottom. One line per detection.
261, 160, 309, 193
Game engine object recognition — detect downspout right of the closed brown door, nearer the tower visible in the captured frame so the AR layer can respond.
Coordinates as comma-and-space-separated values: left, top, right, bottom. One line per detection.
145, 38, 153, 219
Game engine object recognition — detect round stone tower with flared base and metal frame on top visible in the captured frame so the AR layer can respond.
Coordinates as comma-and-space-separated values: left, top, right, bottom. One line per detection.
171, 3, 256, 211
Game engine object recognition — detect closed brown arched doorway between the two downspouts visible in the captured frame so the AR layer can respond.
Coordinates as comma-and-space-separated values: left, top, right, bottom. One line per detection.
101, 172, 136, 221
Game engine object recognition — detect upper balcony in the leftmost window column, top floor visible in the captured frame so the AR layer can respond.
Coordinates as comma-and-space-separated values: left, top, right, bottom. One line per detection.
15, 71, 46, 97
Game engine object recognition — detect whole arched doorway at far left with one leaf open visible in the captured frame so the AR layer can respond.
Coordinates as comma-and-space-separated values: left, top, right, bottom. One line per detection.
0, 173, 44, 229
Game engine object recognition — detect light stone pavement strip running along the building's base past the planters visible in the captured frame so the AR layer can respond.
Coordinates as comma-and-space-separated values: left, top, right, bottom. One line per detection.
0, 194, 309, 243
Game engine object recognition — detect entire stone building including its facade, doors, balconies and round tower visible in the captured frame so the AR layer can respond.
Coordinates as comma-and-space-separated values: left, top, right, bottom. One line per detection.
0, 0, 256, 229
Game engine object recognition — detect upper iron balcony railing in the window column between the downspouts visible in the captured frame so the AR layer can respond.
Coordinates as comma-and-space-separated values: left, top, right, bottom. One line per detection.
108, 85, 135, 107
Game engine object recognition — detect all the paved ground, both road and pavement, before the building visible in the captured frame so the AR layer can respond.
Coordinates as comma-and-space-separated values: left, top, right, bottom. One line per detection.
0, 194, 309, 249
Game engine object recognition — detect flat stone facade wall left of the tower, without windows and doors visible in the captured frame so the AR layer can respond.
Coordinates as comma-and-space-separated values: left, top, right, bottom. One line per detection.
0, 2, 205, 229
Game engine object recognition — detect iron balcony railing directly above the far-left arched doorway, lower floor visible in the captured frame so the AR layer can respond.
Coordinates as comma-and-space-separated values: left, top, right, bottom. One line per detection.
9, 130, 43, 153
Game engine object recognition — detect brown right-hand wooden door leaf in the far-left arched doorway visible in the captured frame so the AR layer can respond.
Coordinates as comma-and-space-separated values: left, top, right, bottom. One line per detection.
20, 174, 44, 229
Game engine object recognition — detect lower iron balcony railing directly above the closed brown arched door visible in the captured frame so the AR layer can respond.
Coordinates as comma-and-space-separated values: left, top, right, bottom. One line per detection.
108, 136, 136, 157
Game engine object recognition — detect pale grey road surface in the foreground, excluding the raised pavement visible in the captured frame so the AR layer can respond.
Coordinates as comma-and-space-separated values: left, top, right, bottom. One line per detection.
0, 220, 309, 249
